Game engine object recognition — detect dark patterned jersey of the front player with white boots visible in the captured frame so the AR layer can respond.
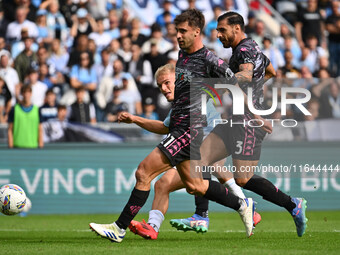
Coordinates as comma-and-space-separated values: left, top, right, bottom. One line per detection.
169, 47, 237, 130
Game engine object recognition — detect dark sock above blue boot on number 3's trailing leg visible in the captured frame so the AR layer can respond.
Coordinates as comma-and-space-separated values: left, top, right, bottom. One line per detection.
243, 175, 296, 212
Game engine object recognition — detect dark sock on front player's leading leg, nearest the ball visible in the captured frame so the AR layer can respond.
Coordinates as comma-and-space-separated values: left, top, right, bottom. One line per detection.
116, 188, 150, 229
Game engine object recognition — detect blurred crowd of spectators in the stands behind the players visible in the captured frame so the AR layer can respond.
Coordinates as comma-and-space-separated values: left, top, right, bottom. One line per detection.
0, 0, 340, 126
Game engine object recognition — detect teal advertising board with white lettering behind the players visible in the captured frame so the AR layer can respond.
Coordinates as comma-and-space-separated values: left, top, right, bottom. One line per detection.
0, 142, 340, 214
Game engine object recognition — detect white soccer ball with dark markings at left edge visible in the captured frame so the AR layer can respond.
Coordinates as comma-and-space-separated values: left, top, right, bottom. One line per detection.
0, 184, 26, 215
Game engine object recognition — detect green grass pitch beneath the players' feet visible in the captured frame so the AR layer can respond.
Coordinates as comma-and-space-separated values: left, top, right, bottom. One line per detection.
0, 211, 340, 255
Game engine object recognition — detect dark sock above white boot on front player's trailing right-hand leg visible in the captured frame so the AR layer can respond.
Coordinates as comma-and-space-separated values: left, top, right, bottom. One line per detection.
203, 180, 240, 210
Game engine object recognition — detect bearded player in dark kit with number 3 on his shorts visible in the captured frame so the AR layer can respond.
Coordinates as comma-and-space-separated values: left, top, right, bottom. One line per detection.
189, 12, 307, 237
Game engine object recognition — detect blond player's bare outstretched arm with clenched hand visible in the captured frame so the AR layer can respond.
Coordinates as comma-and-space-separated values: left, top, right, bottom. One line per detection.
118, 112, 169, 135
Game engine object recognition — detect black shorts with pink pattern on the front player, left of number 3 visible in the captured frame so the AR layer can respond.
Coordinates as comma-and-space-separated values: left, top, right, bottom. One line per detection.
157, 128, 203, 166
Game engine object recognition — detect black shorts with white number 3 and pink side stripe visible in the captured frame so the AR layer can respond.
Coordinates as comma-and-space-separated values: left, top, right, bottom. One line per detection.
211, 117, 267, 161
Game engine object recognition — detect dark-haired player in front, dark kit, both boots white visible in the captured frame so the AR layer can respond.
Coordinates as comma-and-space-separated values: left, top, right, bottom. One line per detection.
90, 9, 264, 242
